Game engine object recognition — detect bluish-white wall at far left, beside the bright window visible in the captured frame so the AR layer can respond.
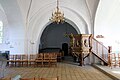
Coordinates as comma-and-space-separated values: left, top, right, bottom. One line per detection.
0, 0, 25, 54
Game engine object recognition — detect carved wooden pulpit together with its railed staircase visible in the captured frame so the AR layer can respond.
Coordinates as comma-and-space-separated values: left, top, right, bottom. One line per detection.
69, 34, 109, 66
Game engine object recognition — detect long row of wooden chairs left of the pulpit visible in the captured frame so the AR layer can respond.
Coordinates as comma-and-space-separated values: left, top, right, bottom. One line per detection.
7, 53, 58, 66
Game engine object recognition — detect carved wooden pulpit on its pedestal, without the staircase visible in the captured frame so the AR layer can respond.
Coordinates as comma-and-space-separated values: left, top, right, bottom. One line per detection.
69, 34, 91, 66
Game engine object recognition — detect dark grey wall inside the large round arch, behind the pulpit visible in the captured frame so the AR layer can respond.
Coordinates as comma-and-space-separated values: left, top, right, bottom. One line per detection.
39, 22, 78, 54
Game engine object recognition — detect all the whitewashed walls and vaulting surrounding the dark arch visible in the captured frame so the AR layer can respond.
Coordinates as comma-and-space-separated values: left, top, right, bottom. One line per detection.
0, 0, 120, 63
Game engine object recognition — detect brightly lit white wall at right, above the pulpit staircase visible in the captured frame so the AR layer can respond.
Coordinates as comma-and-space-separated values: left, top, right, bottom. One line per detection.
94, 0, 120, 52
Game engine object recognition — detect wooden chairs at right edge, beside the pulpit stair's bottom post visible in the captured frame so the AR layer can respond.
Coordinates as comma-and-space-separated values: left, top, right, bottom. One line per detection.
109, 53, 120, 68
